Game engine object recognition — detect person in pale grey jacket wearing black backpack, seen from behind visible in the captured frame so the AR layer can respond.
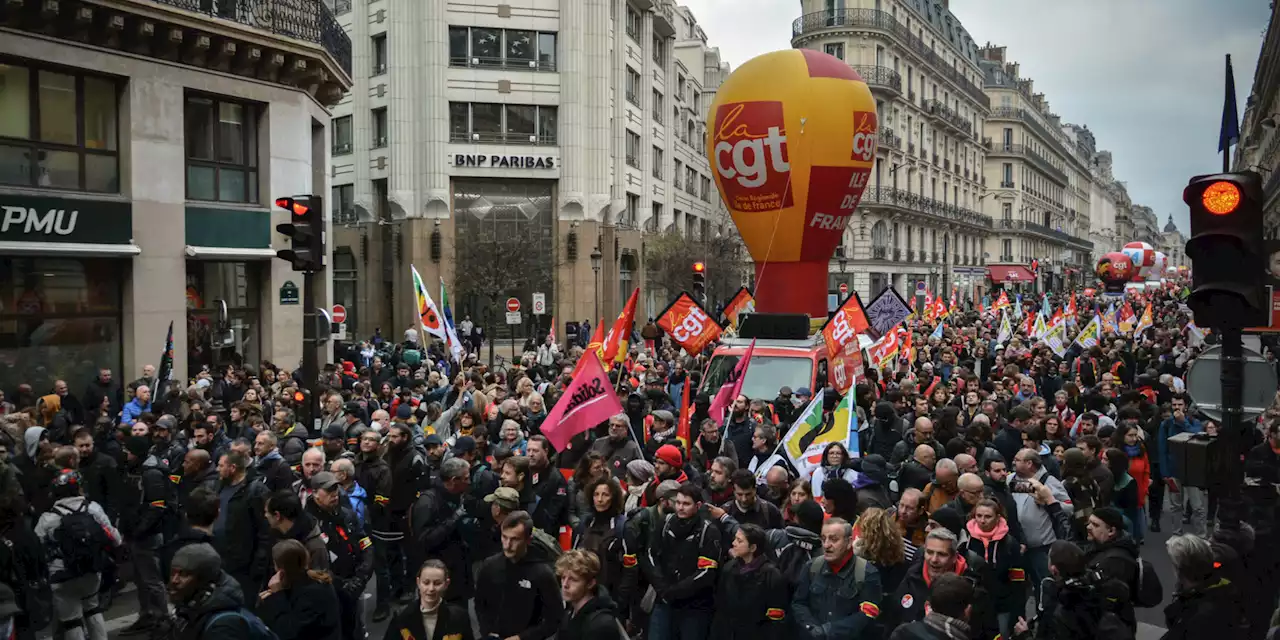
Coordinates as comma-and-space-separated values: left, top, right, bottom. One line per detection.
36, 468, 124, 640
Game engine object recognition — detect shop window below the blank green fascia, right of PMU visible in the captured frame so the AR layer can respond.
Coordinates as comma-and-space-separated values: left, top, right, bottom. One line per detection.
187, 260, 265, 375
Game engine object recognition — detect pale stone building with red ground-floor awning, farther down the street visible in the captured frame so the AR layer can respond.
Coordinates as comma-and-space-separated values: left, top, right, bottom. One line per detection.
980, 45, 1094, 291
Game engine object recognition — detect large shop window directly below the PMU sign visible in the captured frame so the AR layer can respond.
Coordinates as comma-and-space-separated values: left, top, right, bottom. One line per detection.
0, 257, 121, 394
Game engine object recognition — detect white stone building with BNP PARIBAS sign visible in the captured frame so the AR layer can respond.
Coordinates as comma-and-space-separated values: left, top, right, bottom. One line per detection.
332, 0, 731, 338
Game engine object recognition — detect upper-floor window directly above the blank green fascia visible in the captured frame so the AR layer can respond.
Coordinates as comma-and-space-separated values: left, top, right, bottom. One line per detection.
184, 95, 260, 204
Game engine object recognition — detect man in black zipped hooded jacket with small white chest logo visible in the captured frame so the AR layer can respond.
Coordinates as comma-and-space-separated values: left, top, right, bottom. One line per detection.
475, 511, 564, 640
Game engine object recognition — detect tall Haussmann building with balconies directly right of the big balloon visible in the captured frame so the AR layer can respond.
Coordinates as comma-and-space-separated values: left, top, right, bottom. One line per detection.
791, 0, 992, 301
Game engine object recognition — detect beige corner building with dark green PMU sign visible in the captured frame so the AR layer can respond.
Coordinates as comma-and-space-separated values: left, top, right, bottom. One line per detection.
0, 0, 351, 393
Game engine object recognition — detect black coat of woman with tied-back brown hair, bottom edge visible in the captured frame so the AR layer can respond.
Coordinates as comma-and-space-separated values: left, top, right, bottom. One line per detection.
255, 576, 342, 640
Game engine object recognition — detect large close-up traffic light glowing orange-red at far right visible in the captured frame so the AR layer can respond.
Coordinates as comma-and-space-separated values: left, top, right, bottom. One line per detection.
1183, 172, 1270, 329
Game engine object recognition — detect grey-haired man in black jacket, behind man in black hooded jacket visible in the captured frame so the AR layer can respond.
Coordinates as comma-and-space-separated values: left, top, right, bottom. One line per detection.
404, 458, 473, 604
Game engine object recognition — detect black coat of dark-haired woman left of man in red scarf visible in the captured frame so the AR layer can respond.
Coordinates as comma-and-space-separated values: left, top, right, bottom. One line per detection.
710, 556, 790, 640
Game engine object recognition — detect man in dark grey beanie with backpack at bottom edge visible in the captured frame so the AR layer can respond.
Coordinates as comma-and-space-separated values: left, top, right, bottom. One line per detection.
169, 543, 272, 640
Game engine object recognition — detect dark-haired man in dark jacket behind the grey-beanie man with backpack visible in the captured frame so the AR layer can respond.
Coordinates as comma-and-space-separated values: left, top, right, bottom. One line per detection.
212, 452, 271, 604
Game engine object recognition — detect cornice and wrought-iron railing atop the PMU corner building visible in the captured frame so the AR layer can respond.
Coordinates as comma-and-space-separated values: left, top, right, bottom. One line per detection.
0, 0, 351, 105
